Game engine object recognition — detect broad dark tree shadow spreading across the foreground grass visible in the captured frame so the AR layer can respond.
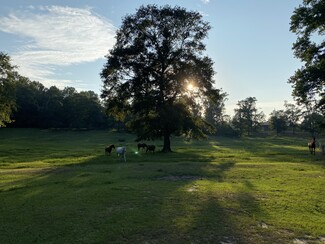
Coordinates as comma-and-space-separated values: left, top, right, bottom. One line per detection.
0, 152, 282, 243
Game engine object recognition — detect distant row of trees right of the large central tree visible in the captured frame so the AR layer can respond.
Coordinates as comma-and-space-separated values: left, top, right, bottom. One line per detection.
210, 97, 325, 136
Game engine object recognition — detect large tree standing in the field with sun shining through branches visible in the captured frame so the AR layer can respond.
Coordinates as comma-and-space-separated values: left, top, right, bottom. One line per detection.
101, 5, 219, 152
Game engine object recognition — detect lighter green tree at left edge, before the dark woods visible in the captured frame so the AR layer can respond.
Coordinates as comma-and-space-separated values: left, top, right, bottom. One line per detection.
0, 52, 18, 127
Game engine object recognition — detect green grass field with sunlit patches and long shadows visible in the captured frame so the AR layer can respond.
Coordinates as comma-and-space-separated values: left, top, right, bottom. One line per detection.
0, 128, 325, 244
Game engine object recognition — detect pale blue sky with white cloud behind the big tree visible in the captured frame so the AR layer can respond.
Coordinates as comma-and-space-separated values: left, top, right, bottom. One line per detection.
0, 0, 302, 115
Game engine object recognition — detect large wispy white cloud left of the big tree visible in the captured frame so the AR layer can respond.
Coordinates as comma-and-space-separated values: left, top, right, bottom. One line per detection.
0, 6, 115, 88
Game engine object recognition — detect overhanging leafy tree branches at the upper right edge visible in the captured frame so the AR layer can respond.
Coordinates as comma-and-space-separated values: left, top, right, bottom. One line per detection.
289, 0, 325, 114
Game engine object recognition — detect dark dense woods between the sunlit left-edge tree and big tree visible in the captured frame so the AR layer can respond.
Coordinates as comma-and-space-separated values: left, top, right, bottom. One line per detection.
10, 77, 109, 128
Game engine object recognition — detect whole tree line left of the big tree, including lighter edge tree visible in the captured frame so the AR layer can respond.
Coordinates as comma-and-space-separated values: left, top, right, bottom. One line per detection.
0, 53, 115, 129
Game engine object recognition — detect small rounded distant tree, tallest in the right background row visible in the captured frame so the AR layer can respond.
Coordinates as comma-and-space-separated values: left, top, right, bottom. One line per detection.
232, 97, 265, 136
